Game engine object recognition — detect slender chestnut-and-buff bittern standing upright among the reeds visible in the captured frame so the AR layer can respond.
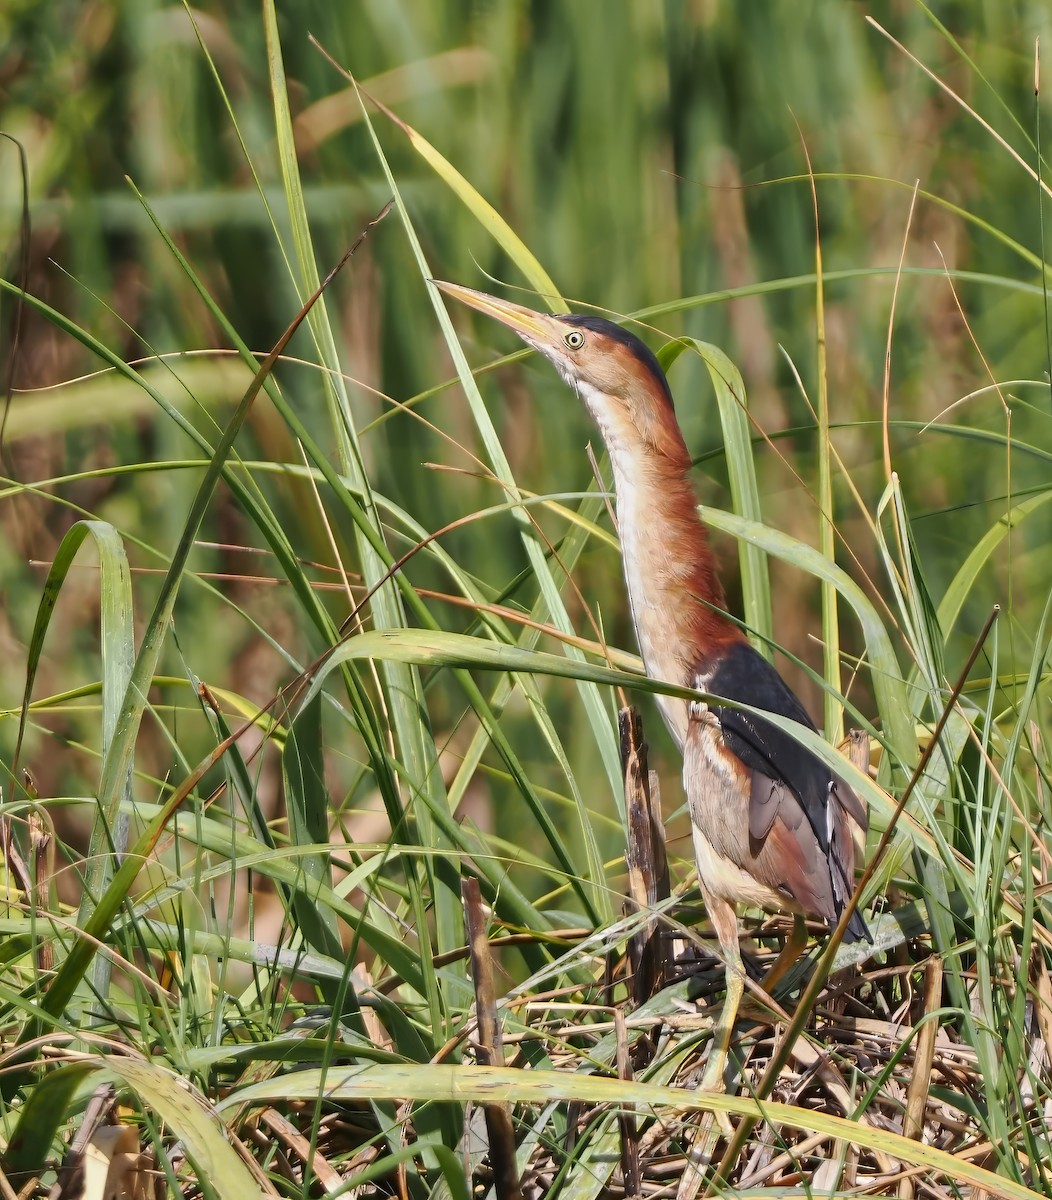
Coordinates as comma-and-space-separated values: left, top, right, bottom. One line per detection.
434, 281, 872, 1091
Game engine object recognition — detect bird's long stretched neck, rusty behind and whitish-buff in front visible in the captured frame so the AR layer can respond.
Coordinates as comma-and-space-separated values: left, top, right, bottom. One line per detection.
608, 428, 744, 743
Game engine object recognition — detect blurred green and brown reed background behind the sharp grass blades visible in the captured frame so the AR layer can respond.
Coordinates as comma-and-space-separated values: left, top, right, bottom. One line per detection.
0, 0, 1050, 878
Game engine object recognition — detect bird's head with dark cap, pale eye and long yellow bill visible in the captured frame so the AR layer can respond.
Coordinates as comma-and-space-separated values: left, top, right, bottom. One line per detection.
435, 280, 690, 466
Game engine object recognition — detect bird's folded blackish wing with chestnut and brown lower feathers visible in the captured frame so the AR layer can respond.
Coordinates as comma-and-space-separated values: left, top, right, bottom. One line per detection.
705, 642, 866, 852
